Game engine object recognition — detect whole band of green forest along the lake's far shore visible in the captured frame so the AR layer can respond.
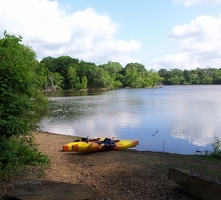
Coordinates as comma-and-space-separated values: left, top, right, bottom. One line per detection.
38, 56, 221, 90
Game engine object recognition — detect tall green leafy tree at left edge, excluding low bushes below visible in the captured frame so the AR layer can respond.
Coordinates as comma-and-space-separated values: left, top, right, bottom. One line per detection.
0, 32, 46, 138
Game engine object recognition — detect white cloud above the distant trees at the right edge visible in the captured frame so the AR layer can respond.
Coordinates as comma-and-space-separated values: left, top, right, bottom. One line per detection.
153, 15, 221, 69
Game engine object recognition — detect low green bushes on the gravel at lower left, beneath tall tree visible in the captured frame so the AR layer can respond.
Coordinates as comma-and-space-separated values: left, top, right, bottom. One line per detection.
0, 135, 50, 182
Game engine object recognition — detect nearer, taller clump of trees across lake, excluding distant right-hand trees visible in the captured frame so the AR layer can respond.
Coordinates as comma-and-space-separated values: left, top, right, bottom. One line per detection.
40, 56, 162, 90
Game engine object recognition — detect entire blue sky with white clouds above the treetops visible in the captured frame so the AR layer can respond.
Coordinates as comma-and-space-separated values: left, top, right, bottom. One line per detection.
0, 0, 221, 71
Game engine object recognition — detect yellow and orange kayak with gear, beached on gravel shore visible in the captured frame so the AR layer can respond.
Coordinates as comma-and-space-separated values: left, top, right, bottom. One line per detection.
63, 138, 139, 152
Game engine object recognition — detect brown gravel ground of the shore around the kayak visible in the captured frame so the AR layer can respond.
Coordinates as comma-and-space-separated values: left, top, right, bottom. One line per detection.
17, 132, 221, 200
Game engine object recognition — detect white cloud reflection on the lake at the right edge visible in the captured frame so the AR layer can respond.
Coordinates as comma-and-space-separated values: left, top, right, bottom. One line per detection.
164, 86, 221, 146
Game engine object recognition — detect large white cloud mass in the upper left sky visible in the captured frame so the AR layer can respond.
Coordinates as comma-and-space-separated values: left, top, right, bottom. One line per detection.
0, 0, 141, 64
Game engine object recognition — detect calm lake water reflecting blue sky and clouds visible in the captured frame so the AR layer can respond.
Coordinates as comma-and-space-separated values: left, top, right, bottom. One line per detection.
39, 86, 221, 154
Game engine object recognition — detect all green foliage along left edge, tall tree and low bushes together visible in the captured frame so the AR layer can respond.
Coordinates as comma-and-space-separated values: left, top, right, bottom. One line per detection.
0, 32, 50, 193
